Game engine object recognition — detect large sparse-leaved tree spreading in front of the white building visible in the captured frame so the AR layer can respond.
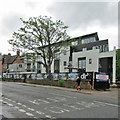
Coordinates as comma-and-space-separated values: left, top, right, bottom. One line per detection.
8, 16, 69, 73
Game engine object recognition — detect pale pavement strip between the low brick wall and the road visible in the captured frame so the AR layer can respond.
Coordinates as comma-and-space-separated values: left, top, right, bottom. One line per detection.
0, 82, 120, 100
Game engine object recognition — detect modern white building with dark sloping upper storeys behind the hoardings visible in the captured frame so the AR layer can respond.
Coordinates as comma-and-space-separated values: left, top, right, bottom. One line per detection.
20, 33, 116, 83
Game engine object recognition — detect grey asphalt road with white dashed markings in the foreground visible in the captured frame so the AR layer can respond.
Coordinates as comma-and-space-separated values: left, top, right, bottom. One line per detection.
0, 82, 119, 119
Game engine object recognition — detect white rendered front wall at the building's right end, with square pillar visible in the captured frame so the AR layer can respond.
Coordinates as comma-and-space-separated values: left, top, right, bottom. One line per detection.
72, 49, 116, 83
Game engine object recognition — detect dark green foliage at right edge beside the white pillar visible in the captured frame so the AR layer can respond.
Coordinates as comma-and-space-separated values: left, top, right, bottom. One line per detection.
116, 49, 120, 77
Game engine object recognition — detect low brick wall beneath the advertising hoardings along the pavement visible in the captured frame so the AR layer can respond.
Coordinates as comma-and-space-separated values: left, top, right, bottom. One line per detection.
4, 79, 91, 89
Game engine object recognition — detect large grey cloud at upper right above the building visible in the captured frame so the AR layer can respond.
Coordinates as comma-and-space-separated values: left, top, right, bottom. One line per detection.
48, 2, 118, 28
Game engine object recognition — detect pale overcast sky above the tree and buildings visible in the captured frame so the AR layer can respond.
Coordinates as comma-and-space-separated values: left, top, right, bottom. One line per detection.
0, 0, 118, 55
